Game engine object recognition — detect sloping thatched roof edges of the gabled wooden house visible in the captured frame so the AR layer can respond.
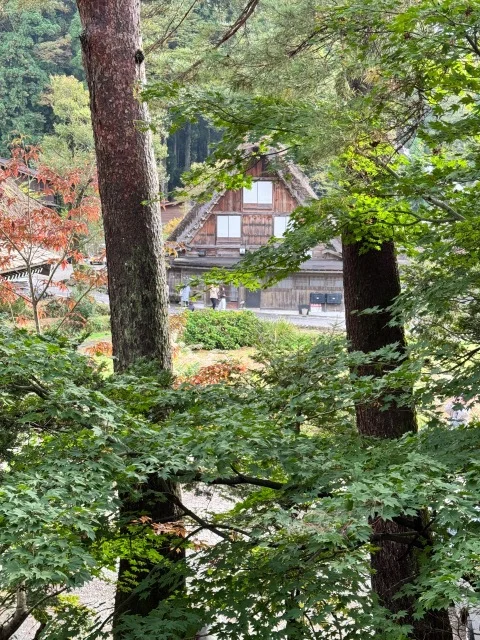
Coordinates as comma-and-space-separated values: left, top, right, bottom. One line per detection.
168, 152, 317, 244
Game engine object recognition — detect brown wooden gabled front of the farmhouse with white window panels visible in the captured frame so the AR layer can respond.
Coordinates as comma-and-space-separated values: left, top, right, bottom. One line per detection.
169, 158, 343, 311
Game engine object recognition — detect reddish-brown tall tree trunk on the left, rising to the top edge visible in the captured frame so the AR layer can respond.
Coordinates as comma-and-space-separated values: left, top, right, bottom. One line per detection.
77, 0, 182, 638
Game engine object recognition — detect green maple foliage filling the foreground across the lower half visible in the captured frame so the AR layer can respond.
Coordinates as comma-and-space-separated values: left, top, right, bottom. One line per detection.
0, 324, 480, 640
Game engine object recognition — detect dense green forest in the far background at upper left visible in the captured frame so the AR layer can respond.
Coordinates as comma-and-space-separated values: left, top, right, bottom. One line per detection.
0, 0, 219, 192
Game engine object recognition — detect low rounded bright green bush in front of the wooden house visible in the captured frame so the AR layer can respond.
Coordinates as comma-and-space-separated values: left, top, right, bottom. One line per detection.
183, 310, 263, 349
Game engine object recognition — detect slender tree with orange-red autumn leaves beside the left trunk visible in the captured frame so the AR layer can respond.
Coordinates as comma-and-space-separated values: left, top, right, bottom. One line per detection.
0, 146, 106, 333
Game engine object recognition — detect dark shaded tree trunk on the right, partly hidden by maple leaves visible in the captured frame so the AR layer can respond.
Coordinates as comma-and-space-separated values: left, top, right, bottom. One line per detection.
343, 241, 452, 640
